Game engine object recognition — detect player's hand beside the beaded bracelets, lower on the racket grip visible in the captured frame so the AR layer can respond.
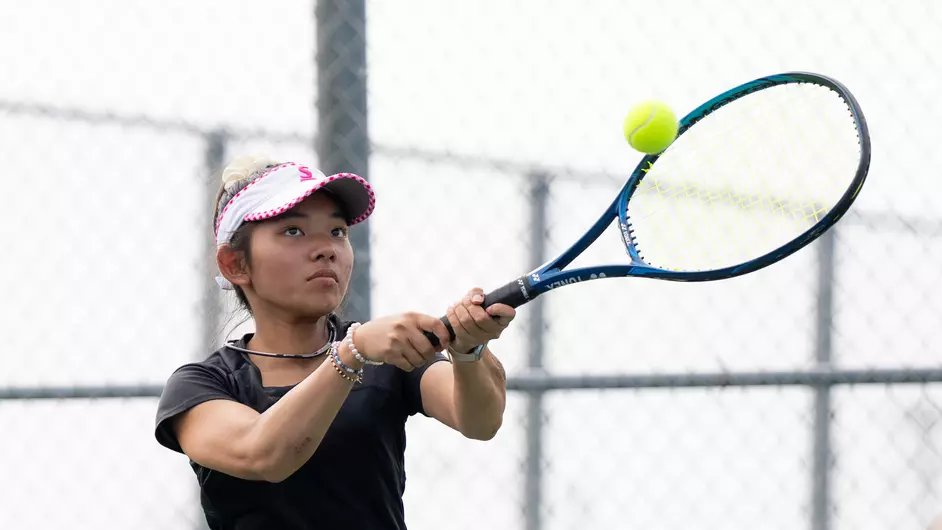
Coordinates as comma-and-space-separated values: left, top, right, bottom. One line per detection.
353, 313, 457, 372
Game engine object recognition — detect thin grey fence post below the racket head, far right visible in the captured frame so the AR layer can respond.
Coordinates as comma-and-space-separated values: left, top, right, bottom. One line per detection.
811, 229, 835, 530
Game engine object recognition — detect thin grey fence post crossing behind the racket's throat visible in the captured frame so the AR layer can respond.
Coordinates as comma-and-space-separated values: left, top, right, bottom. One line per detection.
523, 173, 550, 530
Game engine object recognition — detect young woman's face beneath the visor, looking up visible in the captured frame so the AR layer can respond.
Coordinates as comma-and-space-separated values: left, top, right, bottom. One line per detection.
246, 192, 353, 318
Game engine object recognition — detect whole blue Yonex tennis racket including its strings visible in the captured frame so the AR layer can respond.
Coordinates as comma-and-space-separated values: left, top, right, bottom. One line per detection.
426, 72, 870, 345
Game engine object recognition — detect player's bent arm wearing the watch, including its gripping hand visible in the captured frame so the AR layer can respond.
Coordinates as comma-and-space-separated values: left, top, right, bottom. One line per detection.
420, 289, 516, 440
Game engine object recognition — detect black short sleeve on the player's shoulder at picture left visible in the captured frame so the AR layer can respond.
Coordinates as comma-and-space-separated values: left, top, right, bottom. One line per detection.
155, 364, 238, 453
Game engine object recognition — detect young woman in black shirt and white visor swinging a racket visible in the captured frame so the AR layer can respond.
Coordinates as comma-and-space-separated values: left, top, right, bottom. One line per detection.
156, 155, 515, 530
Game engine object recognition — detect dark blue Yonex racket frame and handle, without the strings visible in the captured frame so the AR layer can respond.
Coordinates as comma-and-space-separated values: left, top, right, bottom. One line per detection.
435, 72, 870, 342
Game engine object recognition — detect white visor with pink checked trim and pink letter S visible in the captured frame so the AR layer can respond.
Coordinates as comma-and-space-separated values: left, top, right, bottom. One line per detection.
216, 162, 376, 247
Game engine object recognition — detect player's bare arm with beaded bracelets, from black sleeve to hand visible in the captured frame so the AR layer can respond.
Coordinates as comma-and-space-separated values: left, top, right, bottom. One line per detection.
172, 314, 449, 482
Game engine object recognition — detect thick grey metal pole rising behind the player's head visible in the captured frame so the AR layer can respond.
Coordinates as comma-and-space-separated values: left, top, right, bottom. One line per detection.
314, 0, 370, 321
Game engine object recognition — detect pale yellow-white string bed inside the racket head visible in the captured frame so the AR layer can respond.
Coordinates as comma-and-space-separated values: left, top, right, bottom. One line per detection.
627, 84, 860, 270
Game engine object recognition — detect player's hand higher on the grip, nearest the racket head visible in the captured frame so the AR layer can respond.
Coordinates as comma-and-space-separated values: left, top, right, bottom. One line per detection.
448, 288, 517, 353
